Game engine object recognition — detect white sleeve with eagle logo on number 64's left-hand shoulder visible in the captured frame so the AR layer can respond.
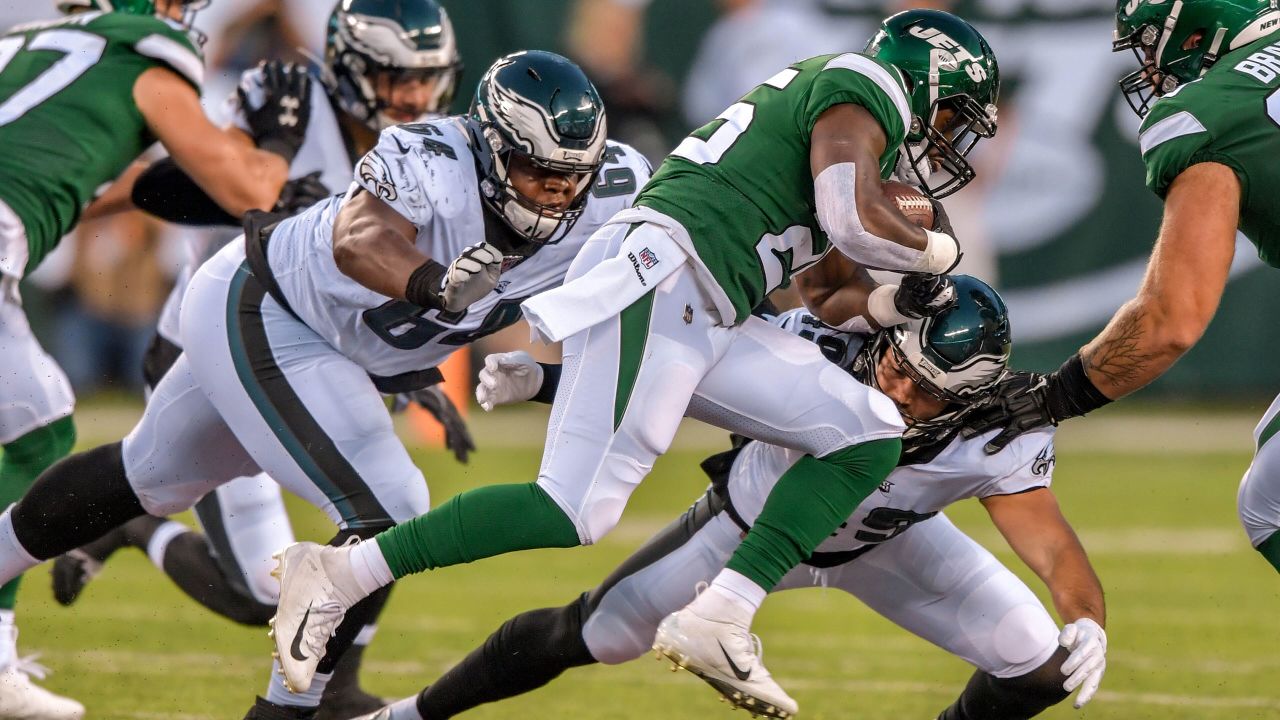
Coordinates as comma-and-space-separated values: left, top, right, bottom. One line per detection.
355, 127, 435, 227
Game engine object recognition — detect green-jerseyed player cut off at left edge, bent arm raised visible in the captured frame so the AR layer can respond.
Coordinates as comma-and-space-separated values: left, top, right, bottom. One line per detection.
0, 0, 306, 717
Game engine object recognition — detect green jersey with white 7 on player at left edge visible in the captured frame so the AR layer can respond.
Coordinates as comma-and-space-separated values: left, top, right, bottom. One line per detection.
0, 13, 204, 277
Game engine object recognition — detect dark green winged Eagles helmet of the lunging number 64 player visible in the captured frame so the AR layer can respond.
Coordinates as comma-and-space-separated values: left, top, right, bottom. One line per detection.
470, 50, 605, 245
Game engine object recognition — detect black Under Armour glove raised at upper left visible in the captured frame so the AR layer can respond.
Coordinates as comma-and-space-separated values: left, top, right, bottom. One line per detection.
244, 60, 311, 163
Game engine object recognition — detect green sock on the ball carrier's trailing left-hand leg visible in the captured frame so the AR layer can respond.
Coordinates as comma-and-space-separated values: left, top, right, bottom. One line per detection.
376, 483, 580, 579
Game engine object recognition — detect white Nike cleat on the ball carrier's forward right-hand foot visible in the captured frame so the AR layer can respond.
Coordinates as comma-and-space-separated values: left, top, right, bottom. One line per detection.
653, 607, 799, 720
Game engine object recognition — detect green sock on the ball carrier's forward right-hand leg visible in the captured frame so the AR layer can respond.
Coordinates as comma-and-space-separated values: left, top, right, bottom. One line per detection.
726, 438, 902, 591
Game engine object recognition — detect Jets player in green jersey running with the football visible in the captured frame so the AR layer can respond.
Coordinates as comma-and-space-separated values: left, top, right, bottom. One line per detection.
274, 10, 1000, 717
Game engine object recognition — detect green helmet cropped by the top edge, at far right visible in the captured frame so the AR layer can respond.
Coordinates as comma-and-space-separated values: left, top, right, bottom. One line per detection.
1111, 0, 1280, 118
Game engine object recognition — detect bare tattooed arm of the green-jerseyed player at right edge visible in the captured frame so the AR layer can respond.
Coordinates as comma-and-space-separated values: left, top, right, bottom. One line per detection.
1080, 163, 1240, 400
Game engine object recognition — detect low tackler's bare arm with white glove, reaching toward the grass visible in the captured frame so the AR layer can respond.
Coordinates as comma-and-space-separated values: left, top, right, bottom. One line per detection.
982, 488, 1107, 708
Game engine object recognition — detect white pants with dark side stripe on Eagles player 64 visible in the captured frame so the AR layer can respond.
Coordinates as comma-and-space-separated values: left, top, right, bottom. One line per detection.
124, 242, 429, 529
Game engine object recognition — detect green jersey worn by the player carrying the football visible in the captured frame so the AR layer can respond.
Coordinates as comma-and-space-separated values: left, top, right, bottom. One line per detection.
636, 53, 910, 323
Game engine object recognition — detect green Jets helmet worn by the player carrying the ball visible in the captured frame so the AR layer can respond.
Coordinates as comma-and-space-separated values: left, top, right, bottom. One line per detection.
864, 10, 1000, 197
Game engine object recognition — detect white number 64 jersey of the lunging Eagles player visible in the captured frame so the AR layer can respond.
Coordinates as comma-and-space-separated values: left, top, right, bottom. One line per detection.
268, 118, 650, 379
